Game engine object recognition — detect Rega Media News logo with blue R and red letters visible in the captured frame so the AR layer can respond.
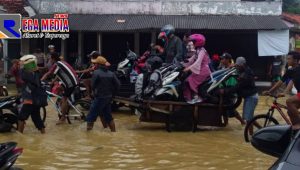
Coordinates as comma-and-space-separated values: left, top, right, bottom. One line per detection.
0, 14, 70, 40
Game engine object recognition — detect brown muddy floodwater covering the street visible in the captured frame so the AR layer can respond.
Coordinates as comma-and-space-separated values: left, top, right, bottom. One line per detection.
0, 98, 282, 170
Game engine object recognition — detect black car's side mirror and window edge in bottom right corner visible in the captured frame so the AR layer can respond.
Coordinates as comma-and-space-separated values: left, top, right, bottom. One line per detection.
251, 125, 300, 170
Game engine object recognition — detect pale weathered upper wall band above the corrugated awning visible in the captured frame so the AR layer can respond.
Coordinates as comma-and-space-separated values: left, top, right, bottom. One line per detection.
28, 0, 282, 15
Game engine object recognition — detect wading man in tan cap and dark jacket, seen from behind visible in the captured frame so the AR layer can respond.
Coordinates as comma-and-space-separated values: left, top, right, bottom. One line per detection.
86, 56, 120, 132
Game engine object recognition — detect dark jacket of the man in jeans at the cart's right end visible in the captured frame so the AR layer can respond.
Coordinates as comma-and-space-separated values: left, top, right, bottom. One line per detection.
225, 66, 257, 98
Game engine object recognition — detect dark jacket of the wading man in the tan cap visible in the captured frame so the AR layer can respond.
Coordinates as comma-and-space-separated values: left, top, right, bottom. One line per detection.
92, 66, 120, 98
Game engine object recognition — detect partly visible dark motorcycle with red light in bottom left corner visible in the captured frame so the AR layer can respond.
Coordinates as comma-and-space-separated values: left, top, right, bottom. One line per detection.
0, 142, 23, 170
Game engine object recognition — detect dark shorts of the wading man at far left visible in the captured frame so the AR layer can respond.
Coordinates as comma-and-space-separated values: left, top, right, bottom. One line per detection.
18, 104, 45, 130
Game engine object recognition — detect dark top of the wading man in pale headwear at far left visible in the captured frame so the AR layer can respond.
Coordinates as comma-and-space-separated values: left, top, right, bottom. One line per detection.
21, 69, 41, 100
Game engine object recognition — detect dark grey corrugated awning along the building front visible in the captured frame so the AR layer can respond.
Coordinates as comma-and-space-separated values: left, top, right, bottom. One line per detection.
34, 14, 288, 31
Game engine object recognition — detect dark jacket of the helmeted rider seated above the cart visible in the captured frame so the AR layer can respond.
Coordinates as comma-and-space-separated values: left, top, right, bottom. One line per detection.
163, 35, 183, 63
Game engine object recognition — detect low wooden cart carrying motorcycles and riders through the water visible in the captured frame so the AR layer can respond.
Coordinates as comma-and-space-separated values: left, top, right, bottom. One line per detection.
114, 97, 241, 132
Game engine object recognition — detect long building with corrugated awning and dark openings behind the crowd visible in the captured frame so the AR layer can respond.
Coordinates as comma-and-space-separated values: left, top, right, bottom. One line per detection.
1, 0, 288, 78
